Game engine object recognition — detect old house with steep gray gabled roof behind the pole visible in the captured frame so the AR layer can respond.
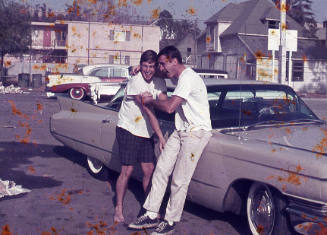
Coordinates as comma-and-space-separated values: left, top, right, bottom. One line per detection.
197, 0, 327, 90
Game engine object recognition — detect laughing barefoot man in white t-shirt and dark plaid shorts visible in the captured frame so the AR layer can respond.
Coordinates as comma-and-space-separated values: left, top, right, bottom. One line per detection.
114, 50, 167, 223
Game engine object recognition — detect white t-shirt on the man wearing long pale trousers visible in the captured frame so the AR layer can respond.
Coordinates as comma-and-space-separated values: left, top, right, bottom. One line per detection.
172, 68, 212, 131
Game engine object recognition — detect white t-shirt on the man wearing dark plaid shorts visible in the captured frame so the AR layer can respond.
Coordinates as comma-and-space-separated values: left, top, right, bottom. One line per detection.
117, 72, 167, 138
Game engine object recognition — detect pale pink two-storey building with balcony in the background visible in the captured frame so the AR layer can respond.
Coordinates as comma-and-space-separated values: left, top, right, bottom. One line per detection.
3, 20, 160, 74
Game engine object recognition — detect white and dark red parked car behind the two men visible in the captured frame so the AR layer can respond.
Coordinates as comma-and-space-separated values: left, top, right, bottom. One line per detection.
46, 64, 129, 100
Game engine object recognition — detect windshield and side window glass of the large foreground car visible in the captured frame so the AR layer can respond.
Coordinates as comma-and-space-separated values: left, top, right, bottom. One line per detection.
207, 85, 320, 128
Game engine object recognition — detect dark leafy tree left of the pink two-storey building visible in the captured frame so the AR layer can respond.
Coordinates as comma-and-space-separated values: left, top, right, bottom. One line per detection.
0, 0, 31, 81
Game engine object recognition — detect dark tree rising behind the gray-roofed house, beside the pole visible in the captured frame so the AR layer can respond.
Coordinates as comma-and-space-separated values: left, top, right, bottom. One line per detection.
273, 0, 317, 33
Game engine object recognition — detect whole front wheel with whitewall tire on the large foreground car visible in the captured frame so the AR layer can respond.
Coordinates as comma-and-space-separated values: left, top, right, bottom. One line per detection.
246, 182, 292, 235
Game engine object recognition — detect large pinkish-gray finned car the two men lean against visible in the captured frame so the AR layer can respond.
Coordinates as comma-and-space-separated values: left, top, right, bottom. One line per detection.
50, 79, 327, 235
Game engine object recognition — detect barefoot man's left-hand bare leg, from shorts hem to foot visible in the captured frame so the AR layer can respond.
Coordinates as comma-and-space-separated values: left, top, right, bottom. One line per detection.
114, 165, 134, 223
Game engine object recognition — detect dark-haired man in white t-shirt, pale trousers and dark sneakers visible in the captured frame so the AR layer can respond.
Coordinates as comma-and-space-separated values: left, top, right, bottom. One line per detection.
129, 46, 212, 235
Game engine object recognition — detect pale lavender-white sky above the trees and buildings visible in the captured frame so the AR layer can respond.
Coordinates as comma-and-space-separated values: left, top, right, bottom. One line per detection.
29, 0, 327, 25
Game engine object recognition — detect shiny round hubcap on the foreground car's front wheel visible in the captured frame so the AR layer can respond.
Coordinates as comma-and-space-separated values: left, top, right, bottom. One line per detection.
250, 187, 275, 235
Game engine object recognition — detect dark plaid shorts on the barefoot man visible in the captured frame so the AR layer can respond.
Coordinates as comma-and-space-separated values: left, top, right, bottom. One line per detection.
116, 126, 155, 165
